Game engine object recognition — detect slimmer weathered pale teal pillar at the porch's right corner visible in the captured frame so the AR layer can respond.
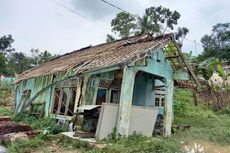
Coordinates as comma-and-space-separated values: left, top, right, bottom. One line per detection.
163, 80, 174, 137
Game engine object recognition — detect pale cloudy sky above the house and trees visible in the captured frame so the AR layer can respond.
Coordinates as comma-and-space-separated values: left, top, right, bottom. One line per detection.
0, 0, 230, 55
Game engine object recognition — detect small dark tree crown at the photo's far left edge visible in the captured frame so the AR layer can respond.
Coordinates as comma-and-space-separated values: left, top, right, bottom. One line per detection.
0, 35, 14, 54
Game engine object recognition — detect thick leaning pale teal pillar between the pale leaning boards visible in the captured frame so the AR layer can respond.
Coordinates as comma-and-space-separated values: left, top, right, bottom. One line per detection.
117, 66, 136, 136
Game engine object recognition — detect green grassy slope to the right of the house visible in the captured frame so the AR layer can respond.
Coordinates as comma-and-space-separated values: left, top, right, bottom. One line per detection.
173, 89, 230, 145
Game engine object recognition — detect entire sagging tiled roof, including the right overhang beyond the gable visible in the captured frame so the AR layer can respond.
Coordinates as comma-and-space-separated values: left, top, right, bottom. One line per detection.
17, 34, 197, 86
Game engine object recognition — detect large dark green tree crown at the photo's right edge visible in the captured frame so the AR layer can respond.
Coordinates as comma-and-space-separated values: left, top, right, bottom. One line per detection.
198, 23, 230, 62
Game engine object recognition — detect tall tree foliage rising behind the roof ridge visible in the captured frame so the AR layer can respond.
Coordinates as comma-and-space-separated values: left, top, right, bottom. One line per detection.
107, 6, 189, 44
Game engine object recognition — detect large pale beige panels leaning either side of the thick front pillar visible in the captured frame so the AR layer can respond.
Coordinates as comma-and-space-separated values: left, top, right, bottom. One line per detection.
95, 103, 158, 140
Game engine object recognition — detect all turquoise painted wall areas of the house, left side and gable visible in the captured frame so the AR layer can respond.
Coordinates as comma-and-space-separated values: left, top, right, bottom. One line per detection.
16, 50, 173, 114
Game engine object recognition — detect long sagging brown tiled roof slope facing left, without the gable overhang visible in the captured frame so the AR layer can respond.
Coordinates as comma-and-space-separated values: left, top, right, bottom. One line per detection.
17, 34, 171, 82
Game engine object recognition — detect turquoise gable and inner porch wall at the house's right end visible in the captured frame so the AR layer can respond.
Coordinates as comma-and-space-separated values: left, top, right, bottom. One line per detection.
133, 50, 173, 114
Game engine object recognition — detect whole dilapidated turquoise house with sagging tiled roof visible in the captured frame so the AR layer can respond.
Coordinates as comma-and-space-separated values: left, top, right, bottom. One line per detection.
16, 34, 197, 139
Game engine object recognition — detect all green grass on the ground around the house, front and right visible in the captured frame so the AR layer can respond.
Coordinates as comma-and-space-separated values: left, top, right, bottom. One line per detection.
0, 89, 230, 153
